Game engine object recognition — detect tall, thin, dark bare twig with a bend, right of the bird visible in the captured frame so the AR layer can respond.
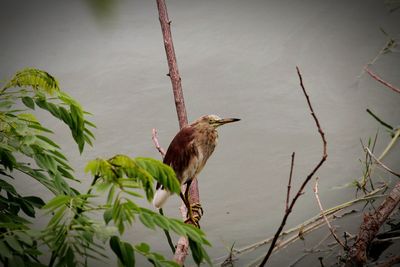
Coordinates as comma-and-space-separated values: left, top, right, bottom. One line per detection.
260, 66, 328, 266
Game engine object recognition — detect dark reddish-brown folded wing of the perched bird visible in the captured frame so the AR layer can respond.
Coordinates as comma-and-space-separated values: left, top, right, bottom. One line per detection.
157, 126, 198, 188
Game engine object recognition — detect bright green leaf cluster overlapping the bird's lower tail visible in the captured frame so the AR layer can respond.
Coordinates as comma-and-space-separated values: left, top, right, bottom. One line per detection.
86, 155, 210, 266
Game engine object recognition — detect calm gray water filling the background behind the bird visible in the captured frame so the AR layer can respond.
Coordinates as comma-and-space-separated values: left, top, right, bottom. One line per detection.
0, 0, 400, 266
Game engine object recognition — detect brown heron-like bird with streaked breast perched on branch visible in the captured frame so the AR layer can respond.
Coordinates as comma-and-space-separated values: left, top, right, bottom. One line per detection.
153, 115, 240, 225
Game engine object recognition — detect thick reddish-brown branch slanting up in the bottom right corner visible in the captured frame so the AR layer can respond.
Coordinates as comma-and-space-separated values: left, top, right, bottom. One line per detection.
346, 182, 400, 267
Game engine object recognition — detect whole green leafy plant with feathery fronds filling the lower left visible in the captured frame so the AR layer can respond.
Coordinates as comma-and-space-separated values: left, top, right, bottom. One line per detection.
0, 68, 209, 266
